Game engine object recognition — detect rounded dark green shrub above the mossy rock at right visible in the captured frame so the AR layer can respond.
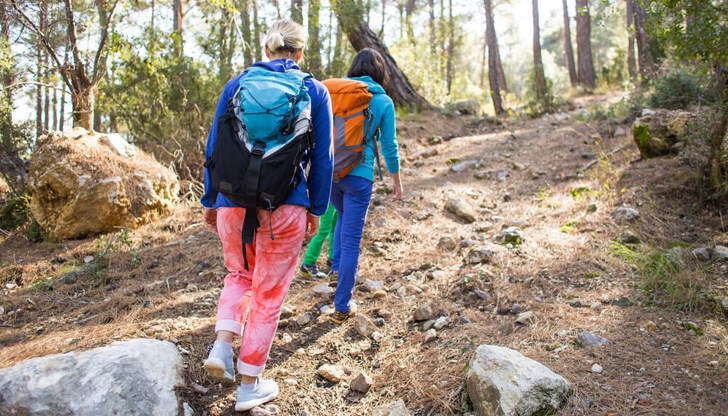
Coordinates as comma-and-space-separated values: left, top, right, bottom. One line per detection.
647, 66, 720, 109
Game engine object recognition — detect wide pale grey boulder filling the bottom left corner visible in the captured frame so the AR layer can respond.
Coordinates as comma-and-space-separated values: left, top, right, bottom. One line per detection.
0, 339, 182, 416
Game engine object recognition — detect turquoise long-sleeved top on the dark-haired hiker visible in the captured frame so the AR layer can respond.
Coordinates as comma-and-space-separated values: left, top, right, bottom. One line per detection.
349, 76, 399, 182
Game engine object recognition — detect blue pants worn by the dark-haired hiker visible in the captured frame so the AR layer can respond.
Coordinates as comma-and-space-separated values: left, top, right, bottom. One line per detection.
331, 175, 373, 312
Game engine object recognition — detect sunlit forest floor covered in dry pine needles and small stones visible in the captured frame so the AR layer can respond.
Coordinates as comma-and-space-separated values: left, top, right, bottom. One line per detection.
0, 96, 728, 416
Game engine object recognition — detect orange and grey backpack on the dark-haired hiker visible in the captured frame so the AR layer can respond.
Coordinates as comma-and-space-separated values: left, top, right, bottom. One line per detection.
322, 78, 379, 181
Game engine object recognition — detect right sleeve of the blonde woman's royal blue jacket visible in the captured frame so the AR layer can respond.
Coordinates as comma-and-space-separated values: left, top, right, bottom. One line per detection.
308, 81, 334, 217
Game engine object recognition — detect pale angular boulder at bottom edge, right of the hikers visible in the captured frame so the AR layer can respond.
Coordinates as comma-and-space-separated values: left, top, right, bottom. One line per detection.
467, 345, 571, 416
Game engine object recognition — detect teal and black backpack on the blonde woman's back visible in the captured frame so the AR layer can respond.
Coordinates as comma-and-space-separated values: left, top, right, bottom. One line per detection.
205, 67, 313, 270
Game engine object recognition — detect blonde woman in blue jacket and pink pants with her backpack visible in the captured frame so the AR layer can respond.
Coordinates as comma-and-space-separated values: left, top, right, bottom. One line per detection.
201, 20, 333, 411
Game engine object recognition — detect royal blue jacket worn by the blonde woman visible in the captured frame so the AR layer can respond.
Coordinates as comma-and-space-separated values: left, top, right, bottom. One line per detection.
200, 59, 334, 215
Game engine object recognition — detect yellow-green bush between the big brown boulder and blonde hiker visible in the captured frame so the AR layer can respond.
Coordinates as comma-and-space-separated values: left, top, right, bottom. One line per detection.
98, 33, 222, 180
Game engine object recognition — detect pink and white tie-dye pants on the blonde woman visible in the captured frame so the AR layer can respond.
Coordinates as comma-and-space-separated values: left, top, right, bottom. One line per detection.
215, 205, 306, 377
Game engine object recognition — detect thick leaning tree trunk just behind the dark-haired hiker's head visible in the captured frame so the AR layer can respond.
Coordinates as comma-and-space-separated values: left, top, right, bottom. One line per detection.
334, 0, 432, 109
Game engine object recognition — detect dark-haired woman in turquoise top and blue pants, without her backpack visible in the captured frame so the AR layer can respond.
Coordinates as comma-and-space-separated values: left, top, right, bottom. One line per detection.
331, 48, 403, 324
